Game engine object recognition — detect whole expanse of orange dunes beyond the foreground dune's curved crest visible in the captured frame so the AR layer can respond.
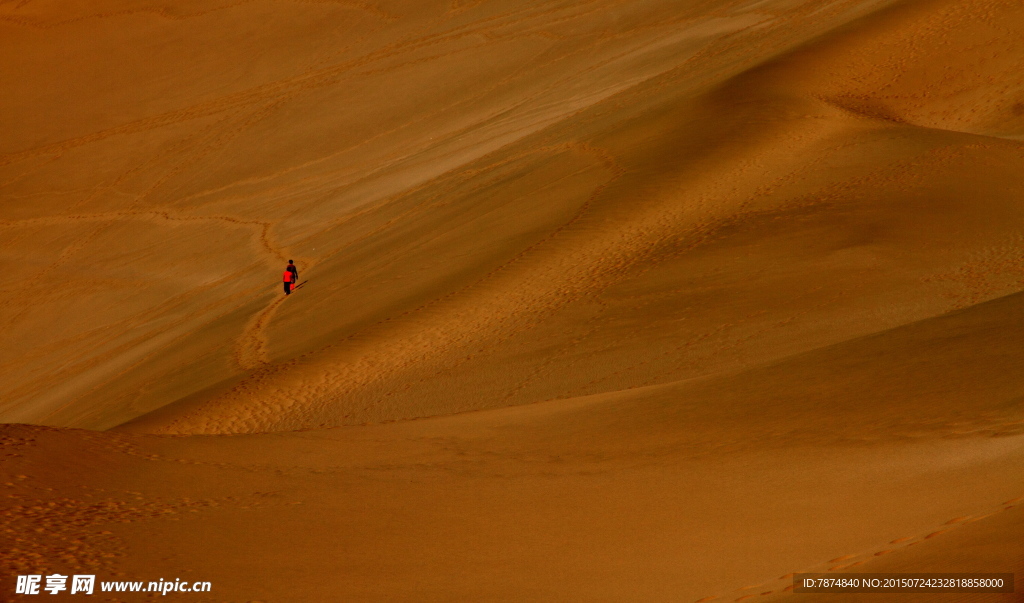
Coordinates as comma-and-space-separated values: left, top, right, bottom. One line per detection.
8, 1, 1024, 432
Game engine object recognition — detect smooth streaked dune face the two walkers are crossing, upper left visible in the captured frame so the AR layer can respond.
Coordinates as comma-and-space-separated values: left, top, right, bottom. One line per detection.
0, 0, 856, 428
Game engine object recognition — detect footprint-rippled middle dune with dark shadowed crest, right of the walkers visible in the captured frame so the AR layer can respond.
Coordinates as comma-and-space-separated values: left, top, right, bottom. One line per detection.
116, 2, 1024, 433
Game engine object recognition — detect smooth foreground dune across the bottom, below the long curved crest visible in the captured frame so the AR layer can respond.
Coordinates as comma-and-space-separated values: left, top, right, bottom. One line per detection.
2, 294, 1024, 601
